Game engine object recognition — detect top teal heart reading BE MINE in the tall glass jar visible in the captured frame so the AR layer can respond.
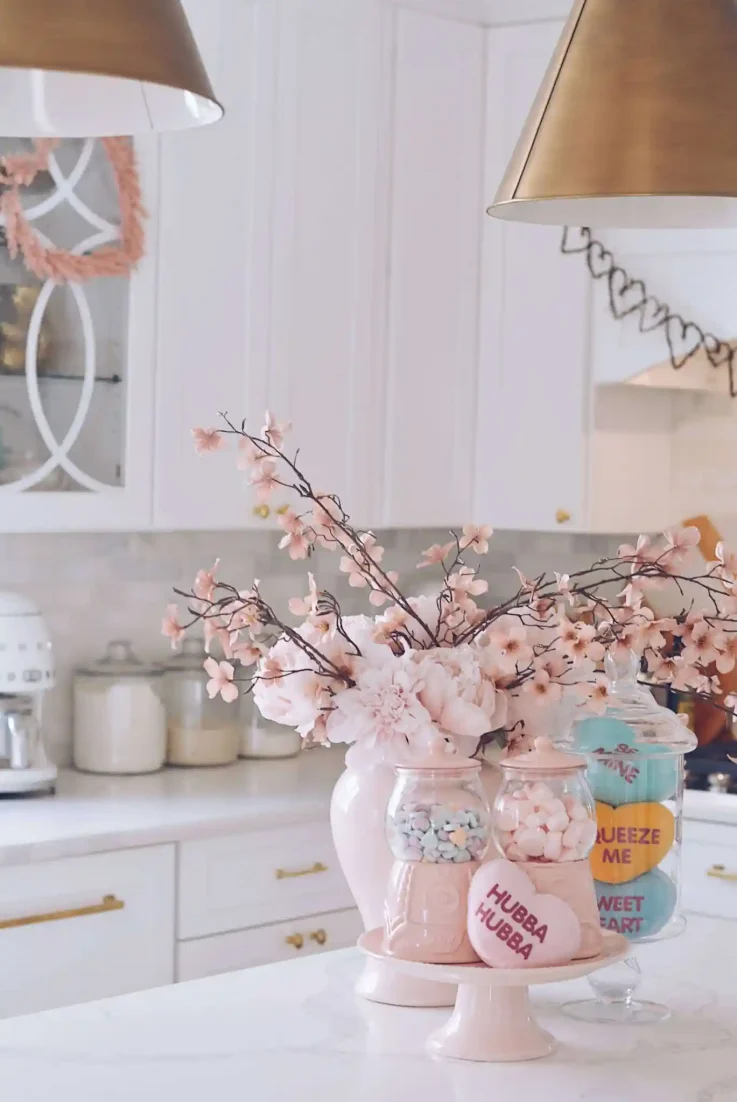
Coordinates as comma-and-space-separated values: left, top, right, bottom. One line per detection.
576, 716, 682, 808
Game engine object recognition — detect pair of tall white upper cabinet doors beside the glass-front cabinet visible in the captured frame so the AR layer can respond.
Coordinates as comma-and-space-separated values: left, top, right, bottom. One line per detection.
155, 0, 389, 528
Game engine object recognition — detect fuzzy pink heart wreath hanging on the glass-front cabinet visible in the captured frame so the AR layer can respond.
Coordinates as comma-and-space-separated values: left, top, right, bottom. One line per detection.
0, 138, 145, 283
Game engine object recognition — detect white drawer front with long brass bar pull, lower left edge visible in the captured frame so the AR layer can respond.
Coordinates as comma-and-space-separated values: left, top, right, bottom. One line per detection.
0, 845, 175, 1017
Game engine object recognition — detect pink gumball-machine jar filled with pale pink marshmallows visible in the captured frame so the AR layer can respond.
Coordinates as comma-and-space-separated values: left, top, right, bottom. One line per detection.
491, 737, 603, 960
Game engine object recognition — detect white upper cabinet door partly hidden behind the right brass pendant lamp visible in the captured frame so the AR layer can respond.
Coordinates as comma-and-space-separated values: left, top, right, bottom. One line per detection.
475, 22, 589, 529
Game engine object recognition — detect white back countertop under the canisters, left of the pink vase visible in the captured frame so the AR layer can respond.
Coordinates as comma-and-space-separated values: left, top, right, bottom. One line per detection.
0, 748, 344, 866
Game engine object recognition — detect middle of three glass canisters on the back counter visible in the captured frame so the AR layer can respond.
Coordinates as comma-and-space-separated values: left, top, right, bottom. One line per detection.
164, 639, 241, 766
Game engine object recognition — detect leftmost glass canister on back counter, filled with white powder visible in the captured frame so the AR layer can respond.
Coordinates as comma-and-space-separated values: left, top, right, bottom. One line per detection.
74, 641, 166, 774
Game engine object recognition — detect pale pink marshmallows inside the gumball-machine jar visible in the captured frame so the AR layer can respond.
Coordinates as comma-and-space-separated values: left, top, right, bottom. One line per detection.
495, 781, 596, 862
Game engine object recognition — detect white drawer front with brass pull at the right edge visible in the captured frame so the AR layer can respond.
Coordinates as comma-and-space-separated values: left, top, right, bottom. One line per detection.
681, 827, 737, 918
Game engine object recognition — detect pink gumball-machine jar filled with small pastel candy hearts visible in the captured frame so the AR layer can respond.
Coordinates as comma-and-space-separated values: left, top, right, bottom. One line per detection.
382, 744, 490, 964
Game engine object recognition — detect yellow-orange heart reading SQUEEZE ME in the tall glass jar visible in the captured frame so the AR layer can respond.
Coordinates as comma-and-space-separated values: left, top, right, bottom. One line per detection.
590, 803, 675, 884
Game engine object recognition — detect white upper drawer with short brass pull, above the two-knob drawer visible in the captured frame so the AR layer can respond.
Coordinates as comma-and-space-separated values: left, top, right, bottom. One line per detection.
177, 823, 354, 940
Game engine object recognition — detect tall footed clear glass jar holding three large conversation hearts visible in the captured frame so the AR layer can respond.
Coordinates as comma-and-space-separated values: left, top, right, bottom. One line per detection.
557, 653, 696, 1022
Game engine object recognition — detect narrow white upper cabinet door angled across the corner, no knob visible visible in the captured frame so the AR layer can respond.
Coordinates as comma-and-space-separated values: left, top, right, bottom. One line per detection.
383, 11, 485, 527
